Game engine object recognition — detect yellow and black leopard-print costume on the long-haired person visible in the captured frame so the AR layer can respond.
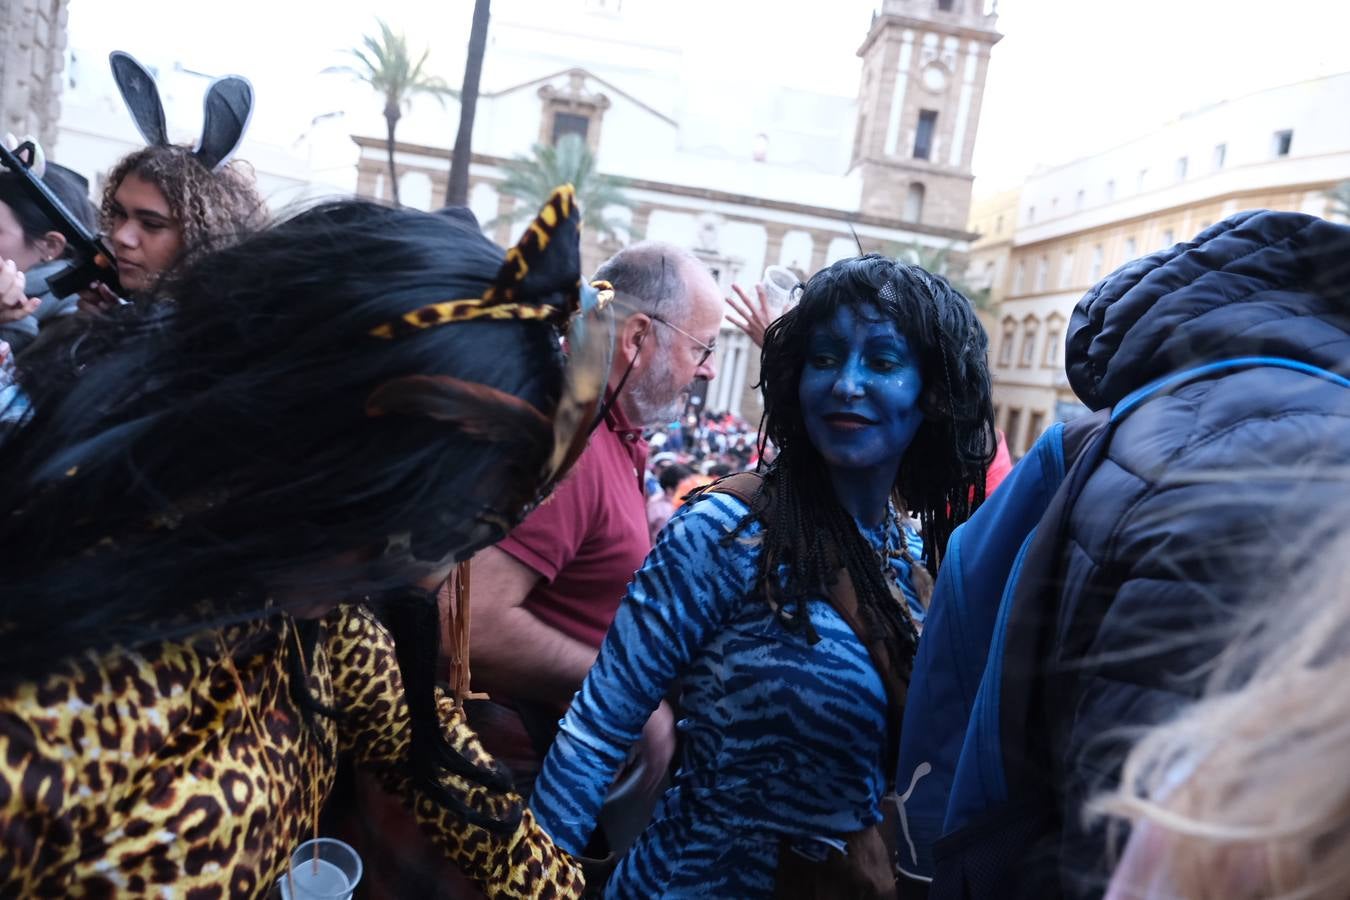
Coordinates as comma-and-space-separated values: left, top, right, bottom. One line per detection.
0, 606, 583, 900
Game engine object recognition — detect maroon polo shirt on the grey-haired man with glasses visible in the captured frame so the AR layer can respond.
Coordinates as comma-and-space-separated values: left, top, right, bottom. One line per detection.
497, 405, 652, 649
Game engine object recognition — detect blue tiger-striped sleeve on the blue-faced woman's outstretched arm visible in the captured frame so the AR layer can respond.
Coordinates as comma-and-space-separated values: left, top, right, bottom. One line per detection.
531, 494, 757, 854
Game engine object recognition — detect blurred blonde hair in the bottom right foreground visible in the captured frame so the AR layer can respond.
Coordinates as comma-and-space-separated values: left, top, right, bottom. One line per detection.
1088, 524, 1350, 900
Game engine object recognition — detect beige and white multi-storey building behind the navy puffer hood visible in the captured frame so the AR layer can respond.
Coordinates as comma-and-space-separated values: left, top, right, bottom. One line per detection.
972, 73, 1350, 456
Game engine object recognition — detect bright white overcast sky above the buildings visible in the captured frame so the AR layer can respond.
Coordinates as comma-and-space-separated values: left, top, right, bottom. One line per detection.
70, 0, 1350, 193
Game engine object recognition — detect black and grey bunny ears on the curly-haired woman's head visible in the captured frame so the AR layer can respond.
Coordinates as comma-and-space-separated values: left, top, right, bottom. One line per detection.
108, 50, 252, 171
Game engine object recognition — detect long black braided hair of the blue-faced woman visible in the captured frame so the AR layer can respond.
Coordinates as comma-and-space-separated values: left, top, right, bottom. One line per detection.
737, 254, 996, 679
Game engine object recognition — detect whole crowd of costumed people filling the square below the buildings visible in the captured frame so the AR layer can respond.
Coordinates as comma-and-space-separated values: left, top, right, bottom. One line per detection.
0, 47, 1350, 900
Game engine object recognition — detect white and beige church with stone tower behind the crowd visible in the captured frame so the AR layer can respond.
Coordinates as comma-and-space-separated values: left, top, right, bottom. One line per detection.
354, 0, 1000, 422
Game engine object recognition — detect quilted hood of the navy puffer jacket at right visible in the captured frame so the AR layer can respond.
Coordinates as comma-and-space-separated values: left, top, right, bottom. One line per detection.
1065, 209, 1350, 410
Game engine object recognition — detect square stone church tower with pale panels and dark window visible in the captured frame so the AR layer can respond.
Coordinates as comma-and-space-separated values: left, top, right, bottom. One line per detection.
849, 0, 1003, 231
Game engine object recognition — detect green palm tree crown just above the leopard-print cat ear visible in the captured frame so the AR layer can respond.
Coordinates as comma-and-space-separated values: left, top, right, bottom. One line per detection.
489, 135, 633, 237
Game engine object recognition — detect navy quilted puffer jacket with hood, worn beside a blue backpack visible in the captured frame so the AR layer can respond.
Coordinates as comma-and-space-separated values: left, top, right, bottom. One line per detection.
1046, 212, 1350, 897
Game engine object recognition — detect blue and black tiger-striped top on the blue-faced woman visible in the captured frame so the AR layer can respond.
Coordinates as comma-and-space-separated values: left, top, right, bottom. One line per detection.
531, 494, 922, 899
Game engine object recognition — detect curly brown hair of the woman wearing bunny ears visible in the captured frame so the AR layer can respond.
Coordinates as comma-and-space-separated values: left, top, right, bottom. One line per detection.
100, 144, 267, 275
